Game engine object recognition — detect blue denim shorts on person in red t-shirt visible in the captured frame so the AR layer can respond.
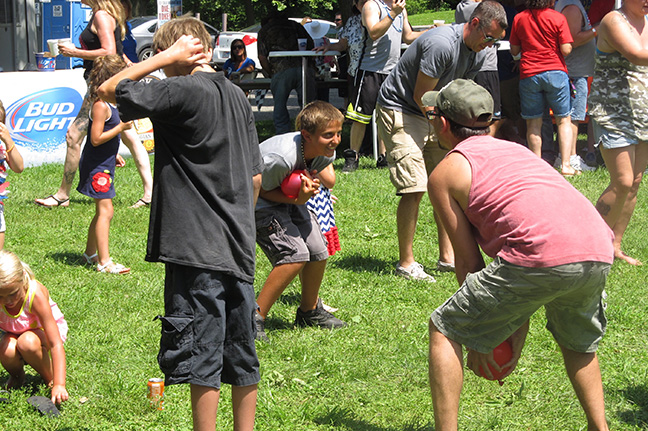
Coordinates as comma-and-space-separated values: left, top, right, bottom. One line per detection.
520, 70, 571, 120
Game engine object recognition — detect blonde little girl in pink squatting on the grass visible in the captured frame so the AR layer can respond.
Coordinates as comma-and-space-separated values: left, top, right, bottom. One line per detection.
0, 250, 68, 404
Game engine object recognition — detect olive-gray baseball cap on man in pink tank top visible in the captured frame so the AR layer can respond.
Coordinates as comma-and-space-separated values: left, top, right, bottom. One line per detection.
421, 79, 493, 129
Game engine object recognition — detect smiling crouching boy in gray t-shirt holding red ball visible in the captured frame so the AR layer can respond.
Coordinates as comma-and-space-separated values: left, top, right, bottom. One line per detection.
255, 101, 346, 341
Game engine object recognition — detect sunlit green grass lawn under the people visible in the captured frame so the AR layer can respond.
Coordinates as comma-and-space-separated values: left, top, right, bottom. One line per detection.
0, 127, 648, 431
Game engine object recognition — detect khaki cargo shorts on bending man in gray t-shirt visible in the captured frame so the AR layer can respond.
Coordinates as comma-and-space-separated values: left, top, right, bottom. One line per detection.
376, 105, 448, 195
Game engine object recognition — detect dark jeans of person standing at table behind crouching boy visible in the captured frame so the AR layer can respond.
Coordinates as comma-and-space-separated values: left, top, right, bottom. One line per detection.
270, 67, 316, 134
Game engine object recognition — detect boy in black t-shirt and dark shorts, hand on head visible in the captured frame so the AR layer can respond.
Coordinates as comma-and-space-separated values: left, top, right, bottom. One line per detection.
99, 18, 263, 430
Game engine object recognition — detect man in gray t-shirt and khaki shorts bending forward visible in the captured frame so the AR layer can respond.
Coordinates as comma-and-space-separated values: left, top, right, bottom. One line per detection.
376, 0, 507, 281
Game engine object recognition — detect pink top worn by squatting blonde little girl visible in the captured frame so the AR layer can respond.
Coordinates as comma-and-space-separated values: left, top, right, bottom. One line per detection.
0, 280, 68, 342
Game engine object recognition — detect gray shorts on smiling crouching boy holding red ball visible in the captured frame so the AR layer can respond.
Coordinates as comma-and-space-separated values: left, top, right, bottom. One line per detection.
254, 204, 329, 267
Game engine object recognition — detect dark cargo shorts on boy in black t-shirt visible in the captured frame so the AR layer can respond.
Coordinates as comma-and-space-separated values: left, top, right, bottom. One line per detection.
158, 263, 260, 389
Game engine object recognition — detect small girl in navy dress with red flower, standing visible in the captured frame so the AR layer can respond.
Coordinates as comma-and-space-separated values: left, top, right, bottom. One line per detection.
77, 55, 133, 274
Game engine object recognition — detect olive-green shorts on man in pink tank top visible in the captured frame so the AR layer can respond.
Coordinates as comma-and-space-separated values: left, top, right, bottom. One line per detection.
430, 257, 610, 353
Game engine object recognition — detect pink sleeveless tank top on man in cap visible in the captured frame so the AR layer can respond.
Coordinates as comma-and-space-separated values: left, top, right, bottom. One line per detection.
453, 136, 614, 267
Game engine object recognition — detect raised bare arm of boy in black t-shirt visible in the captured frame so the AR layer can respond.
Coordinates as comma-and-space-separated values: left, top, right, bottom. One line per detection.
98, 35, 207, 103
